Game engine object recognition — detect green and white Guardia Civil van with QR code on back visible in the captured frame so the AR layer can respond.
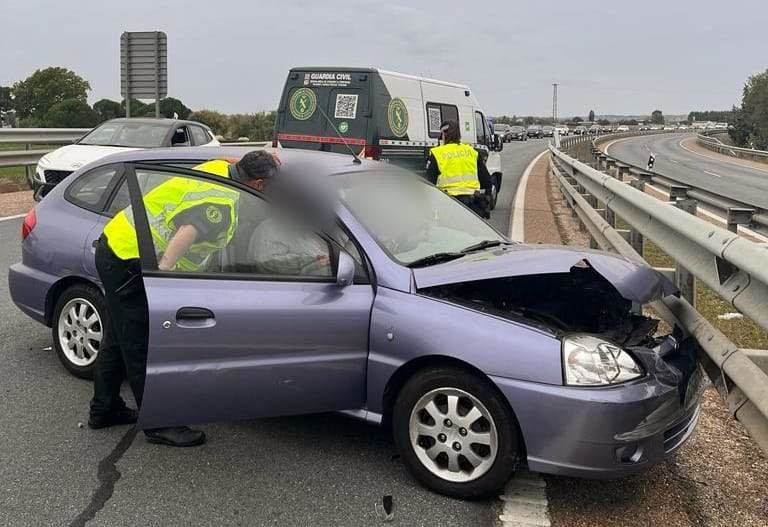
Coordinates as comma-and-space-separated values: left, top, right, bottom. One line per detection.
274, 67, 503, 208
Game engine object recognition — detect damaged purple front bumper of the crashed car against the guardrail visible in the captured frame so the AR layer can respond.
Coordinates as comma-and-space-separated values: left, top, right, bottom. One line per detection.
492, 338, 703, 479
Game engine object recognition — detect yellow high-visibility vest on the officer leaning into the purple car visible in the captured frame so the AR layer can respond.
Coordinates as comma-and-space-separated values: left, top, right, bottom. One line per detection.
104, 160, 240, 271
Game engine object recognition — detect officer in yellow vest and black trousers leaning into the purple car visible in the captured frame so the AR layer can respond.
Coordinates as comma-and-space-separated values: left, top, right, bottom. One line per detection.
88, 151, 278, 446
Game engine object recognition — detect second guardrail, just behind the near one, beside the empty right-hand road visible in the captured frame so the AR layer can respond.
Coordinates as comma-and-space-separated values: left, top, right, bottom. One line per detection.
562, 132, 768, 233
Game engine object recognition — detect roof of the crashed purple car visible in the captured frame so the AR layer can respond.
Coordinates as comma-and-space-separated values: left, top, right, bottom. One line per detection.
98, 146, 387, 176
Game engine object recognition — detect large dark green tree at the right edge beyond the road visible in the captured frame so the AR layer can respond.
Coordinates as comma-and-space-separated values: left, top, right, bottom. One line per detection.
730, 70, 768, 150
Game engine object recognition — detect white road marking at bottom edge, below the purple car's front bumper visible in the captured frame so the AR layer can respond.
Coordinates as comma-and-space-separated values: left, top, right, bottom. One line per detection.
499, 471, 550, 527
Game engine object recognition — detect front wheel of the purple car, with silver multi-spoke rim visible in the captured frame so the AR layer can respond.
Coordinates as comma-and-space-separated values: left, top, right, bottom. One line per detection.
392, 367, 521, 500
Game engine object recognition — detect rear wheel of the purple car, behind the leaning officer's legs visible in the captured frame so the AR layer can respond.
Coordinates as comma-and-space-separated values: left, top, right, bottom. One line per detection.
51, 284, 107, 379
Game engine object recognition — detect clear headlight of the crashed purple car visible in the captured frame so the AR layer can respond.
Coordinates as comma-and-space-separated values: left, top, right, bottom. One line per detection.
563, 335, 644, 386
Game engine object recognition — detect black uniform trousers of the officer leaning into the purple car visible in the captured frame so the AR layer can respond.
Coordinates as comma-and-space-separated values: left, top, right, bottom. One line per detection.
91, 235, 149, 416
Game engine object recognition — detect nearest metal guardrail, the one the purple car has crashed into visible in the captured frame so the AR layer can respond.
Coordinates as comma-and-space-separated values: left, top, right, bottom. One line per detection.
550, 138, 768, 453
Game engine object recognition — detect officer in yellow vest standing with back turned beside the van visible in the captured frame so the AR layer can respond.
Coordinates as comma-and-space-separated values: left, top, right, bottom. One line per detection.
426, 121, 493, 218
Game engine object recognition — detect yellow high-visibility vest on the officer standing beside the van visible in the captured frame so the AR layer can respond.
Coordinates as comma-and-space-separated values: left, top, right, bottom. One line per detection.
430, 143, 480, 196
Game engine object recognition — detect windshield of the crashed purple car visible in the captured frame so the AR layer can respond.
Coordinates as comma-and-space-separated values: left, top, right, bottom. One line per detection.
339, 173, 507, 265
